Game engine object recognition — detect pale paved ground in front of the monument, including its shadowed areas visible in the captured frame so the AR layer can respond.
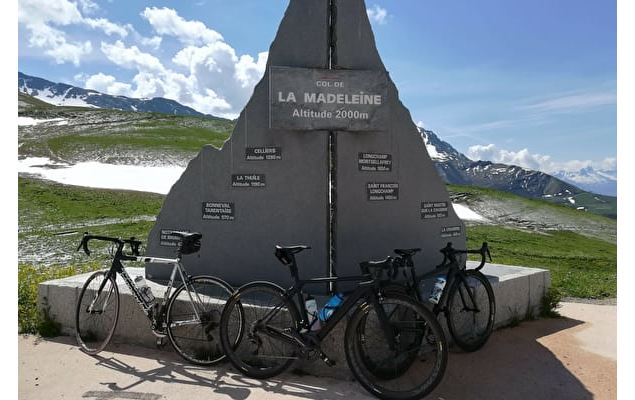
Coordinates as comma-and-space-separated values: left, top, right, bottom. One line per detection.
18, 303, 617, 400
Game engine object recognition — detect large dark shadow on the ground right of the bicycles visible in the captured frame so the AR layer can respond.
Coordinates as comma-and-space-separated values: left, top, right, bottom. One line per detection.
429, 318, 599, 400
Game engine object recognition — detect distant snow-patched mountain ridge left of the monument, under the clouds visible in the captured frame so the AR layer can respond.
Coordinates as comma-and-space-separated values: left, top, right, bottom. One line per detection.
18, 72, 206, 116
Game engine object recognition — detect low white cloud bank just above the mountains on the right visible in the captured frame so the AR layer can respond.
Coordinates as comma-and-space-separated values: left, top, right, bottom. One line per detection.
467, 144, 617, 173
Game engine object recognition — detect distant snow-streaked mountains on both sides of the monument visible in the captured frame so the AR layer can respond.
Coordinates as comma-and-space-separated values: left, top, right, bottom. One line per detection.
18, 73, 617, 218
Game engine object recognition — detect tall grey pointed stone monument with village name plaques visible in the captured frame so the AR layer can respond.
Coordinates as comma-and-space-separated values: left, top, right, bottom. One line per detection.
146, 0, 465, 292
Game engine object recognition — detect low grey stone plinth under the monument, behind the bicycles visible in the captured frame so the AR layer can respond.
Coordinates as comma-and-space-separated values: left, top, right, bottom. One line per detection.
38, 262, 551, 379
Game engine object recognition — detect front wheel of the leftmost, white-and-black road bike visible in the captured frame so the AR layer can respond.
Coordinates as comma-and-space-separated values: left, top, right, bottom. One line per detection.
75, 270, 119, 355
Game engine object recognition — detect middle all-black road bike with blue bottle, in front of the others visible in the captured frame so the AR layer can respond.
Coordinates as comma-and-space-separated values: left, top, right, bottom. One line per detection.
220, 246, 448, 399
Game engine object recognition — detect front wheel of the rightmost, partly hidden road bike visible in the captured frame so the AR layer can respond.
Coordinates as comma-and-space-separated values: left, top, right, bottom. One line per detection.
445, 270, 496, 352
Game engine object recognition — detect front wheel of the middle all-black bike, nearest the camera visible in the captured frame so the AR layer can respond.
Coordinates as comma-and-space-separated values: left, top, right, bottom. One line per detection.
344, 293, 448, 400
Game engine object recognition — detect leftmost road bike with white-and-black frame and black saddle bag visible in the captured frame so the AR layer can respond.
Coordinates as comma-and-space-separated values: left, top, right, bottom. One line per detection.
75, 232, 240, 365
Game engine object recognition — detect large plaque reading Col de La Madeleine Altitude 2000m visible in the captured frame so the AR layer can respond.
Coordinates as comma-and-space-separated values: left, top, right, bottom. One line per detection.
269, 67, 388, 131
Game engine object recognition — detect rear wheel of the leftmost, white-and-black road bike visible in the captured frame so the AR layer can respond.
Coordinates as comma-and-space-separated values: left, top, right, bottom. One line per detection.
165, 276, 234, 365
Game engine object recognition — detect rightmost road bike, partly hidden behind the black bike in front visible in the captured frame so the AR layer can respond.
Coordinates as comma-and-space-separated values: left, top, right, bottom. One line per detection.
386, 243, 496, 352
